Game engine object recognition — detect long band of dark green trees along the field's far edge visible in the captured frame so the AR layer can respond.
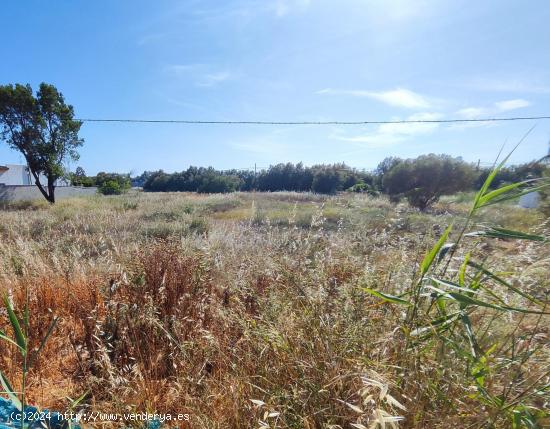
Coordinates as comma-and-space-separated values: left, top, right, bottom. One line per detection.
71, 154, 547, 209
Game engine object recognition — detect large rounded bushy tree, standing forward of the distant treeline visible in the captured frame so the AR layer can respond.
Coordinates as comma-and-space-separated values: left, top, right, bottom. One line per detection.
382, 154, 475, 210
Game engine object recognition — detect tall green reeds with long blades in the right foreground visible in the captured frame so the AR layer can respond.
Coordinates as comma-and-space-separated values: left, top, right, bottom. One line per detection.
365, 149, 550, 428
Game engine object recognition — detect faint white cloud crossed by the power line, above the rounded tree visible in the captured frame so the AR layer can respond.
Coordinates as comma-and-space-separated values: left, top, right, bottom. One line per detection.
332, 112, 442, 149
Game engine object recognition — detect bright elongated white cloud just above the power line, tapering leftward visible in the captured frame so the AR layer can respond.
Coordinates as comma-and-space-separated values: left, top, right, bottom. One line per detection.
317, 88, 432, 109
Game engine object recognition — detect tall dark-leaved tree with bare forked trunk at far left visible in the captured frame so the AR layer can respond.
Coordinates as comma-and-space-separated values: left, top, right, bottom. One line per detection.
0, 83, 84, 203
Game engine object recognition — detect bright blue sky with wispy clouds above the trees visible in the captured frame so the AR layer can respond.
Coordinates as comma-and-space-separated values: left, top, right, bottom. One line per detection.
0, 0, 550, 174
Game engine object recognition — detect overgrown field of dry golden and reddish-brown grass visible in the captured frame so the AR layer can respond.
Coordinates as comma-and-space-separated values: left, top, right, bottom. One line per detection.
0, 193, 550, 429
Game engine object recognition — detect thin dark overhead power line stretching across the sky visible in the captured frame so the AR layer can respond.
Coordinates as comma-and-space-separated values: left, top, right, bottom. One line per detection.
77, 116, 550, 125
